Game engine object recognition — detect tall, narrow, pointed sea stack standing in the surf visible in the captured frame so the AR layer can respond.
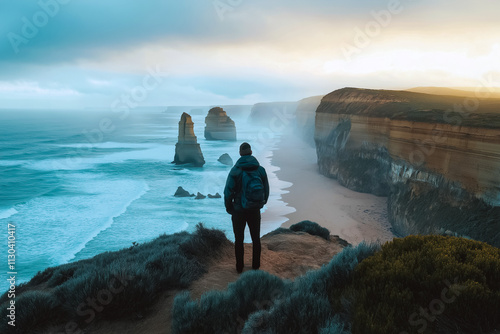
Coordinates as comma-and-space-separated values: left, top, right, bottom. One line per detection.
174, 113, 205, 167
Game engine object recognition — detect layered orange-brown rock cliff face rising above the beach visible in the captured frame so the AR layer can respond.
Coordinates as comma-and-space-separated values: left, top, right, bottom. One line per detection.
315, 88, 500, 246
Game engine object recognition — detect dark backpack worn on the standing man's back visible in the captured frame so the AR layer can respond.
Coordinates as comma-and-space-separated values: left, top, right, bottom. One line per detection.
241, 169, 266, 209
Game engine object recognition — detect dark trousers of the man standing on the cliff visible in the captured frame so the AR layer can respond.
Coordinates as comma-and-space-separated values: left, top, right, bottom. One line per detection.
231, 209, 261, 272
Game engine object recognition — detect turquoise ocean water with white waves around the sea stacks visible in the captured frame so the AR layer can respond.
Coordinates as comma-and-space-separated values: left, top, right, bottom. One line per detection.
0, 107, 293, 291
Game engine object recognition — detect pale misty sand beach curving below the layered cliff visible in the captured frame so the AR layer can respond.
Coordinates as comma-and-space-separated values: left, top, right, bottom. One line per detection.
272, 133, 394, 244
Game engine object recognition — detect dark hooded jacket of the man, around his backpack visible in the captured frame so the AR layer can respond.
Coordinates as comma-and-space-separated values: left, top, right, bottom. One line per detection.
224, 155, 269, 214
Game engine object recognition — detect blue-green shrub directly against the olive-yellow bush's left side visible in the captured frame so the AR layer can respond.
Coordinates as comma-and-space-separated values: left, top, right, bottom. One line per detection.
243, 242, 379, 333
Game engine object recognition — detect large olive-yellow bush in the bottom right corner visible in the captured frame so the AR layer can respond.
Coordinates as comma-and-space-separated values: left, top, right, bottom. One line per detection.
352, 236, 500, 334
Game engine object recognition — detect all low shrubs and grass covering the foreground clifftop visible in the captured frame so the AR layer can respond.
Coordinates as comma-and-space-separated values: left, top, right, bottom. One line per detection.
0, 221, 500, 334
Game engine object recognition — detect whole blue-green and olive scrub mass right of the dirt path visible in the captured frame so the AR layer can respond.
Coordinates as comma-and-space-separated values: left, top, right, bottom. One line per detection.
172, 232, 500, 334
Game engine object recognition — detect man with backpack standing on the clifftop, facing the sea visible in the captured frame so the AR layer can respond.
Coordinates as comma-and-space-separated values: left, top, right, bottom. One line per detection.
224, 143, 269, 273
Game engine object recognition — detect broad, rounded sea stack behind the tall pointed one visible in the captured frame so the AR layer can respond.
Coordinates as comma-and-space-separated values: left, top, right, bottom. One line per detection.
205, 107, 236, 141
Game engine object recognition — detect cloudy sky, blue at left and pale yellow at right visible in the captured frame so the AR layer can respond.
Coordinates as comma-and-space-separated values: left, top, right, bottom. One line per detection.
0, 0, 500, 108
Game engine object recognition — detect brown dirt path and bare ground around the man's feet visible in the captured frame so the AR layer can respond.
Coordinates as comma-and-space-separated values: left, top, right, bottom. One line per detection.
85, 232, 345, 334
